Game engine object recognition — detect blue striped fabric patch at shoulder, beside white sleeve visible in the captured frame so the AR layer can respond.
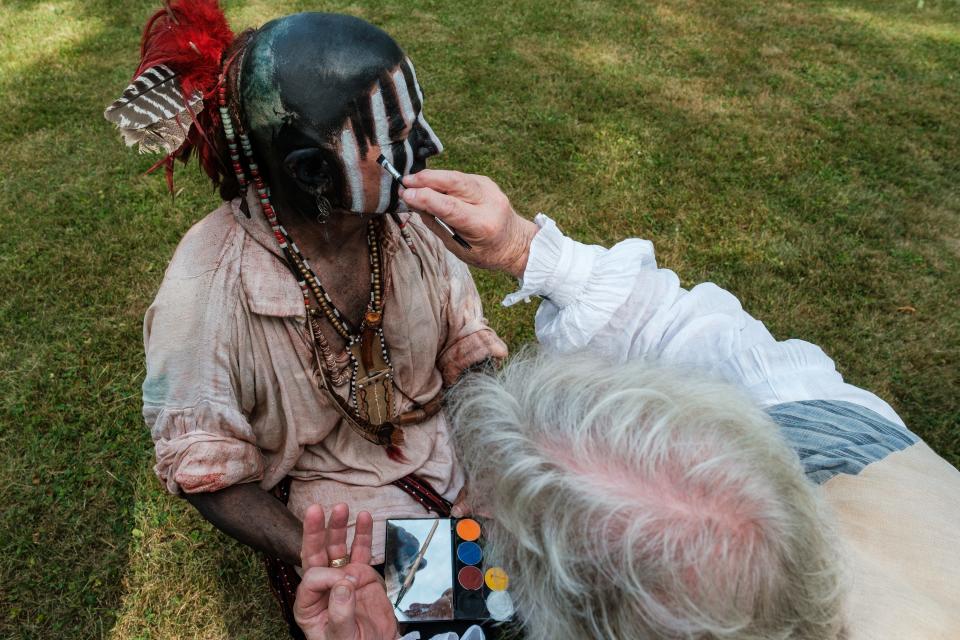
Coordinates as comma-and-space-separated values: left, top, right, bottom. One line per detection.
767, 400, 919, 484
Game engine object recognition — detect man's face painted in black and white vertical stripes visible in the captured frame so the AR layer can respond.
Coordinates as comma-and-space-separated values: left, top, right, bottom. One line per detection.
337, 58, 443, 213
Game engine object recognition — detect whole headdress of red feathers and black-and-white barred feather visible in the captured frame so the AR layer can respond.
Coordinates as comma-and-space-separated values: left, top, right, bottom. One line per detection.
103, 0, 234, 189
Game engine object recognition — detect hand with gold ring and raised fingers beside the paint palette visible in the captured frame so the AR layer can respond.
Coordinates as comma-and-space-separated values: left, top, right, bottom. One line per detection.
293, 504, 398, 640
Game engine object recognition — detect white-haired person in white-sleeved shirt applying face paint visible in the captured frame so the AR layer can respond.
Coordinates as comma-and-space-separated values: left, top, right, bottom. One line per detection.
288, 170, 960, 640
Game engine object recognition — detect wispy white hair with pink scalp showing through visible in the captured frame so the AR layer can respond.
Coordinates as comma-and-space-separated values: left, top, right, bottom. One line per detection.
450, 352, 843, 640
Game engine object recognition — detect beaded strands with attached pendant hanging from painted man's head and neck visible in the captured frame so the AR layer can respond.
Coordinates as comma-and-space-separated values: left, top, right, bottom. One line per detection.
218, 84, 402, 445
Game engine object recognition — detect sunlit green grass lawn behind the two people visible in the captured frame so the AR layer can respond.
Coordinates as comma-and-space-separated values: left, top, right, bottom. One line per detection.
0, 0, 960, 640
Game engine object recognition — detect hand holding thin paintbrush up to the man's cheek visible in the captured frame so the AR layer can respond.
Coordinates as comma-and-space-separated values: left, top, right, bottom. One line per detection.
400, 169, 539, 278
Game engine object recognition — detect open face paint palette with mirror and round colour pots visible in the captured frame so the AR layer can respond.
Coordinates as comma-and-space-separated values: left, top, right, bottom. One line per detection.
384, 518, 513, 622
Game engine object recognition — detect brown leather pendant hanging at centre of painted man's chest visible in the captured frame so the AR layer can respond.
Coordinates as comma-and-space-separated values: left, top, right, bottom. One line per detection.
350, 311, 393, 426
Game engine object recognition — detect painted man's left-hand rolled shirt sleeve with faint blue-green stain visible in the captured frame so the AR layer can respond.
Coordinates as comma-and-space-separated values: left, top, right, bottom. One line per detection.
143, 218, 263, 493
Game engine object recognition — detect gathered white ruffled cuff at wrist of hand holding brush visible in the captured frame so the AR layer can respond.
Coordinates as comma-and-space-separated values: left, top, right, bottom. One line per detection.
502, 213, 600, 308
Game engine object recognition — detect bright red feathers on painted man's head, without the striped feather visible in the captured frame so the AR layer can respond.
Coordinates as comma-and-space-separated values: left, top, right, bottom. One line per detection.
133, 0, 234, 193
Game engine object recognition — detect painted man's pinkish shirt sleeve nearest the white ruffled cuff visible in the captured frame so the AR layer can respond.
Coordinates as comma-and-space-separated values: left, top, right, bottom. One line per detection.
437, 249, 507, 385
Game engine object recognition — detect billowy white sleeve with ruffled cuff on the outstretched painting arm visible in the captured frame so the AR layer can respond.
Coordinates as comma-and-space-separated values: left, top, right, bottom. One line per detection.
503, 214, 903, 424
